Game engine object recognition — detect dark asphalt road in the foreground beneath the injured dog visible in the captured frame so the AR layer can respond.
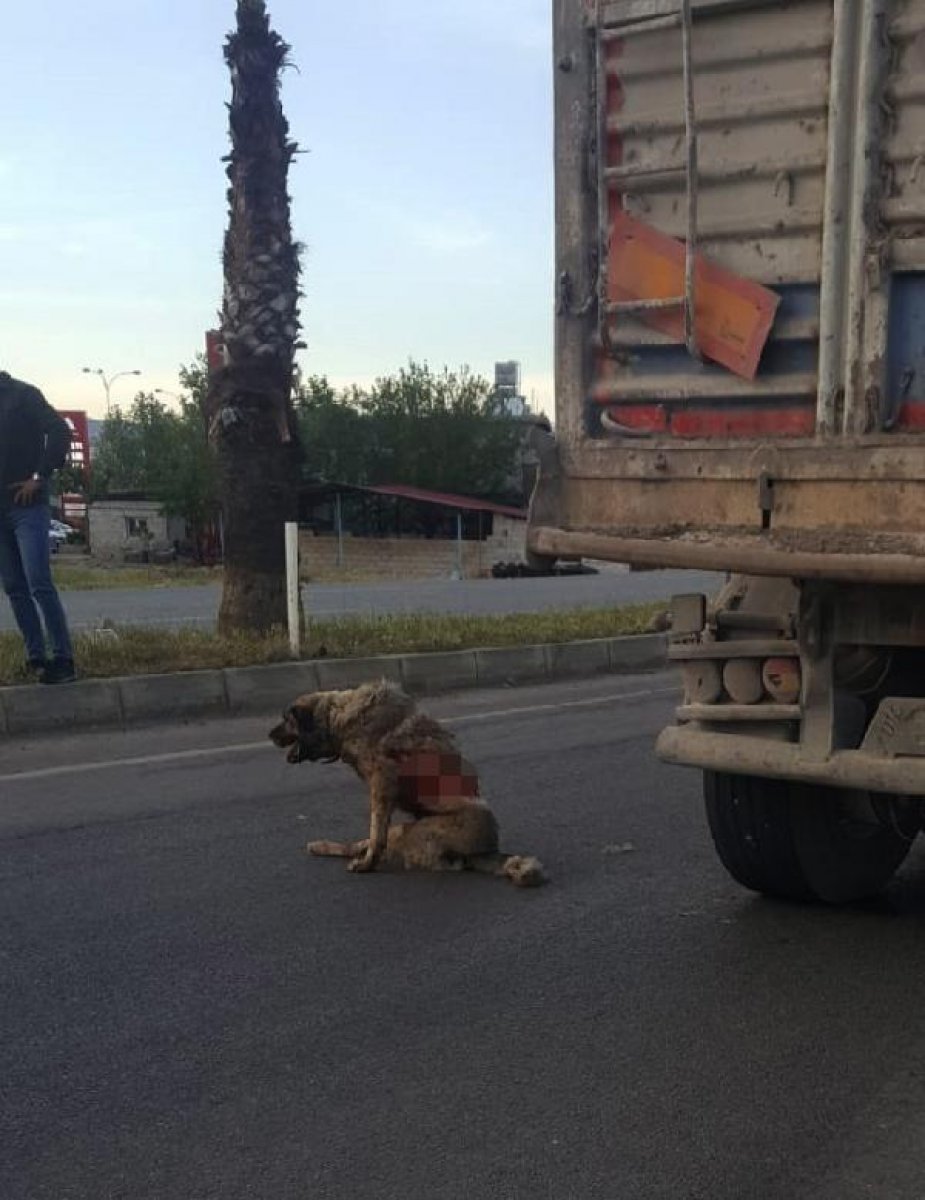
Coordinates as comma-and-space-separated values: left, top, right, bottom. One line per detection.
7, 674, 925, 1200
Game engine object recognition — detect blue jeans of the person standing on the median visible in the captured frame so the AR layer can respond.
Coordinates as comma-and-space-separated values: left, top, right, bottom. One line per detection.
0, 504, 74, 662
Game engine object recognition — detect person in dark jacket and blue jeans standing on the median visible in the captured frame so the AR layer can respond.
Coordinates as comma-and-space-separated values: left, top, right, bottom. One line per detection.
0, 371, 76, 684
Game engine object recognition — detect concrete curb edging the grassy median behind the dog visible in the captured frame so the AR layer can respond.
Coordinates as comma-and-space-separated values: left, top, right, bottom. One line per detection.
0, 634, 666, 739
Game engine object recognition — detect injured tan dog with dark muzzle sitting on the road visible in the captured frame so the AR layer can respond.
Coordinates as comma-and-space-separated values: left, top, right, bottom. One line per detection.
270, 682, 546, 887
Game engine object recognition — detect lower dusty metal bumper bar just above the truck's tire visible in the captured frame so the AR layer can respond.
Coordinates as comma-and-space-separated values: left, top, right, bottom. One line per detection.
656, 725, 925, 796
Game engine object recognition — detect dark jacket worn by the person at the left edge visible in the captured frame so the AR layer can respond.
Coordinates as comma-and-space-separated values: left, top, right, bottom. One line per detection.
0, 371, 71, 508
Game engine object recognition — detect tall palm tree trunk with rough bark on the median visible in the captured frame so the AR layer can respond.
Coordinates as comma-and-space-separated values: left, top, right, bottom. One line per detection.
206, 0, 301, 632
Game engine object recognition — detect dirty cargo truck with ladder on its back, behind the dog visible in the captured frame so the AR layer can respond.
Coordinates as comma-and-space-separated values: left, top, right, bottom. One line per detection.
528, 0, 925, 904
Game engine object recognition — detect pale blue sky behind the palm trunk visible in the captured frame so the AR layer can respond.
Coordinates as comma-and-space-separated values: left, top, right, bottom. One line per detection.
0, 0, 554, 416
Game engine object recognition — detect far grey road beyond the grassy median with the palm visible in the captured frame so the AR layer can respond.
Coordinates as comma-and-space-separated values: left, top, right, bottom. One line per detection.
0, 570, 721, 630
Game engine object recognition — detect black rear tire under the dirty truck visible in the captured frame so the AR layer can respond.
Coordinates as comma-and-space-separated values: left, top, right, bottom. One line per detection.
703, 772, 915, 904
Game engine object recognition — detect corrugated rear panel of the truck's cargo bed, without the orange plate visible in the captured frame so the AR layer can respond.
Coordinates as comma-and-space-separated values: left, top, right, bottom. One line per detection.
539, 0, 925, 582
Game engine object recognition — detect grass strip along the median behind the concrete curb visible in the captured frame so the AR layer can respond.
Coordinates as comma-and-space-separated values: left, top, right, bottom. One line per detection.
0, 602, 665, 686
